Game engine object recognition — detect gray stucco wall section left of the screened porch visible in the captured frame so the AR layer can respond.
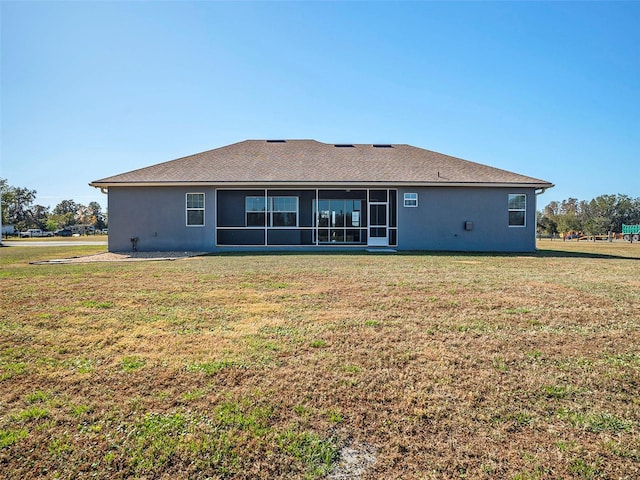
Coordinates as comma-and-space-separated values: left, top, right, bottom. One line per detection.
109, 187, 215, 252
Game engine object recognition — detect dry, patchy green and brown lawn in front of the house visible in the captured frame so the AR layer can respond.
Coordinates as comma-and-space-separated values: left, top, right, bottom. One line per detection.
0, 241, 640, 480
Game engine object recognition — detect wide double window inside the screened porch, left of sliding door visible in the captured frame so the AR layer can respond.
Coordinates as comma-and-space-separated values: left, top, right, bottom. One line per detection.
245, 197, 298, 227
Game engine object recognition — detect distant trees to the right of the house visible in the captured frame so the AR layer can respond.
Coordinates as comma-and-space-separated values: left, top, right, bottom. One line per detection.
537, 194, 640, 235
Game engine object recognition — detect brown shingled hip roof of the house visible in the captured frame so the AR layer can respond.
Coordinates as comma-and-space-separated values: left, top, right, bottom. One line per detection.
90, 140, 553, 188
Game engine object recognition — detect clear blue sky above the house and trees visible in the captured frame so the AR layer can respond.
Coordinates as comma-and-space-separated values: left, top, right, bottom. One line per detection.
0, 1, 640, 212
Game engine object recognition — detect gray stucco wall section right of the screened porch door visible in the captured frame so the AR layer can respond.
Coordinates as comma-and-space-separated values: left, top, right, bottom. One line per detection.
398, 187, 536, 252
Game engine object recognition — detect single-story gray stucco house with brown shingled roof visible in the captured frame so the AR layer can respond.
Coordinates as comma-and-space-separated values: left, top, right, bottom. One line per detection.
90, 140, 553, 252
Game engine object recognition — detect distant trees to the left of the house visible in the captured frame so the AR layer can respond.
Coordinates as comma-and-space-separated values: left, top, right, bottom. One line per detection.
0, 178, 107, 231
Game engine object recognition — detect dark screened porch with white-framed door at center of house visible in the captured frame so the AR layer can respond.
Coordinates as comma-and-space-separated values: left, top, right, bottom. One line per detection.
216, 188, 397, 246
